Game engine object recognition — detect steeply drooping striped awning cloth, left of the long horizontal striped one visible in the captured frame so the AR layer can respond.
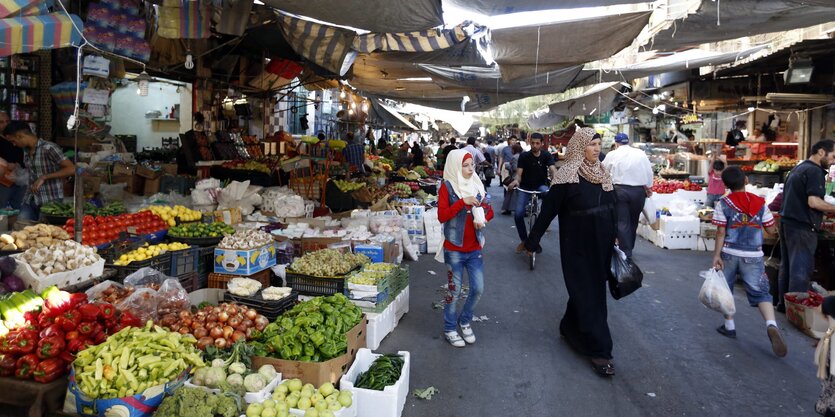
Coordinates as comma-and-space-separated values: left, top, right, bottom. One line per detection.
279, 13, 356, 76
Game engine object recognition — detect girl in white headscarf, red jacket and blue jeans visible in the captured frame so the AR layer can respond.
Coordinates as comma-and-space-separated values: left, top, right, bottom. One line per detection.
438, 149, 493, 347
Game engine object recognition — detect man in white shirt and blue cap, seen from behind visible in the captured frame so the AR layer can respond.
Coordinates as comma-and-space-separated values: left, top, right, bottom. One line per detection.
603, 133, 653, 257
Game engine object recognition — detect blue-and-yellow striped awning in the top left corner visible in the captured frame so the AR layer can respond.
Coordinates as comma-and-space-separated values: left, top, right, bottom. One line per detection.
0, 13, 84, 56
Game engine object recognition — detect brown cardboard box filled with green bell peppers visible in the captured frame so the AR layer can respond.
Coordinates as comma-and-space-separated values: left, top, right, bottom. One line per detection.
252, 315, 367, 387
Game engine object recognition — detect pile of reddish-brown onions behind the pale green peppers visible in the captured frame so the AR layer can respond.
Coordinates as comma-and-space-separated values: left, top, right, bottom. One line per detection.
160, 303, 270, 350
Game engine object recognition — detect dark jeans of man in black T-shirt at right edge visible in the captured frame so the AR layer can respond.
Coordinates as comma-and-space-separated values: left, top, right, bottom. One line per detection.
777, 223, 818, 306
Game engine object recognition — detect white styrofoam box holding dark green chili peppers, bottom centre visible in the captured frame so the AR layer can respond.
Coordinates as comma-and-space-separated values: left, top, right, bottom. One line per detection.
339, 348, 411, 417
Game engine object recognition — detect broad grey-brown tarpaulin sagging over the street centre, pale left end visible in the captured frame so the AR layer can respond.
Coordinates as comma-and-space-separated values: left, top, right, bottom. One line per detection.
492, 11, 652, 79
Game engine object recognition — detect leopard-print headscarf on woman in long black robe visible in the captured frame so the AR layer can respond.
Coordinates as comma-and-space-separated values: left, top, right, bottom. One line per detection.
551, 127, 614, 191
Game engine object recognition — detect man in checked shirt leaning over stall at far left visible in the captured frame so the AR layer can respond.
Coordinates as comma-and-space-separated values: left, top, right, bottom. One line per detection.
3, 122, 75, 220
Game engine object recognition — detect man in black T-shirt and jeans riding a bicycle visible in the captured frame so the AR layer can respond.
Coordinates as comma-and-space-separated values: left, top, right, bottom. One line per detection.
509, 133, 557, 245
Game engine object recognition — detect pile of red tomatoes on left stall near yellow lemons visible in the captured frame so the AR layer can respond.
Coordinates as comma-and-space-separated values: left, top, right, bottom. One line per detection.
64, 211, 168, 246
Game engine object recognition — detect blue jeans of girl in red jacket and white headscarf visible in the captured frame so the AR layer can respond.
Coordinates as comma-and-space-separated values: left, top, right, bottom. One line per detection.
444, 249, 484, 332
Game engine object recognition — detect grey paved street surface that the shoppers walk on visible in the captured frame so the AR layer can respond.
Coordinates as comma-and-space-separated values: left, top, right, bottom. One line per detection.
378, 187, 820, 417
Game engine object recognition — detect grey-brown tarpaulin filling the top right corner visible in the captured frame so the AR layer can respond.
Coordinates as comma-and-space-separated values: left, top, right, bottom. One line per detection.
647, 0, 835, 51
